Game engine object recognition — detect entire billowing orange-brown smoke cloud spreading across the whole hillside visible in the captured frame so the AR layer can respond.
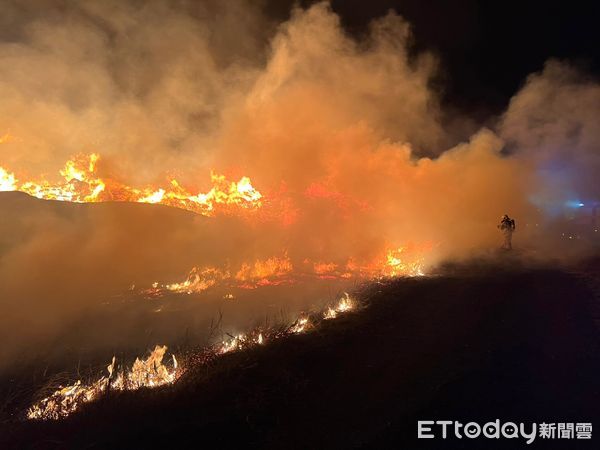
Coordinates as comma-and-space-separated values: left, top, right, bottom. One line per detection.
0, 0, 600, 370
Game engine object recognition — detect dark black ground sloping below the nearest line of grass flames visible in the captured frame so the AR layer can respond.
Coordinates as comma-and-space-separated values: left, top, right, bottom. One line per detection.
0, 258, 600, 449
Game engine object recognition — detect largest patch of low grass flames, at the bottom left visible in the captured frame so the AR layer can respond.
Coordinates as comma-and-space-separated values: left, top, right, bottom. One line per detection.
27, 345, 179, 420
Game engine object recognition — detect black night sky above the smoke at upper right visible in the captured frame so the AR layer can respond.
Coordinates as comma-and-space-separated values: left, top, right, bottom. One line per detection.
270, 0, 600, 116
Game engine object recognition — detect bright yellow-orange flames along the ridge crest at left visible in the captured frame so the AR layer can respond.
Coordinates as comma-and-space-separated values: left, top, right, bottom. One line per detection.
0, 153, 263, 216
